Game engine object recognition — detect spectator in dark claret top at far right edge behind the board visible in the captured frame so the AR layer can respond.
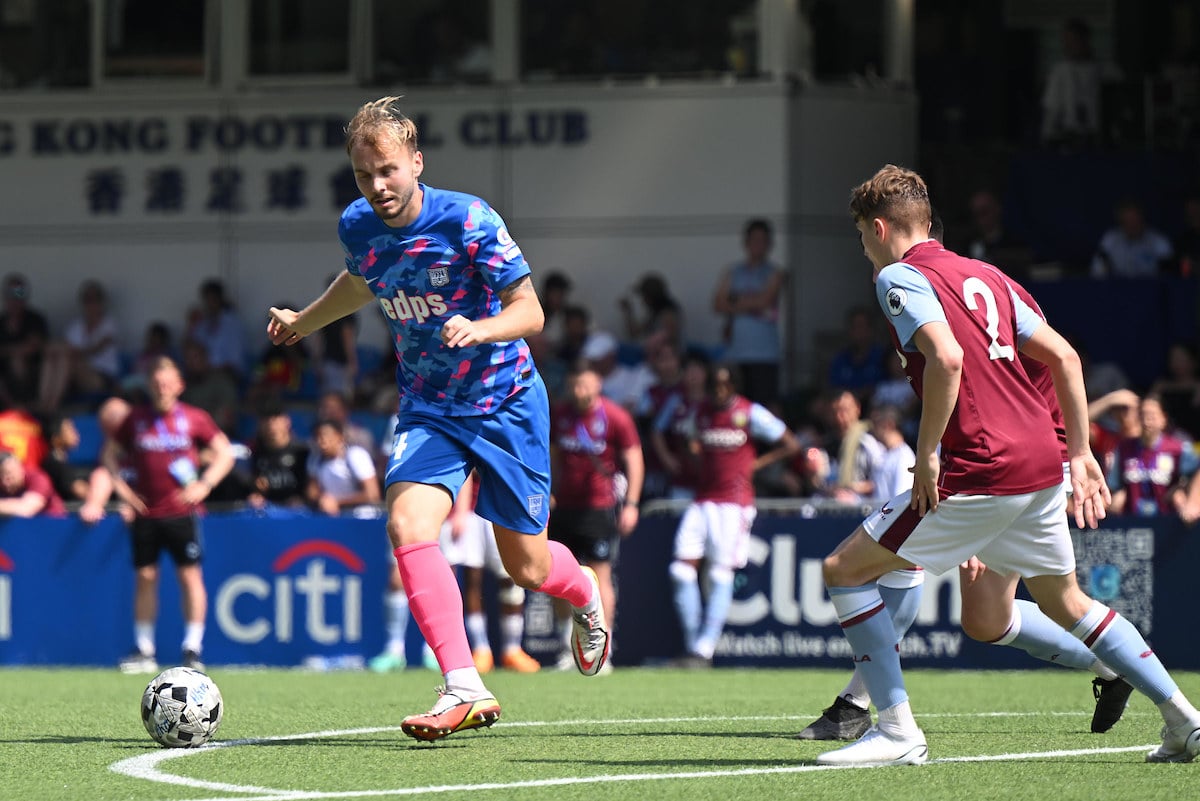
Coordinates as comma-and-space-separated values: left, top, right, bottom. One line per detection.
1109, 395, 1200, 524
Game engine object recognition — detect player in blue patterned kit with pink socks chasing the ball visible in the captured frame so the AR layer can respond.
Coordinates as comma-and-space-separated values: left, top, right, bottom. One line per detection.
266, 97, 610, 740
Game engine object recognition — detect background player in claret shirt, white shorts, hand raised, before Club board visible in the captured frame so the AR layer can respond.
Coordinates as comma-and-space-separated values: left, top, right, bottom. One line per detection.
670, 365, 799, 667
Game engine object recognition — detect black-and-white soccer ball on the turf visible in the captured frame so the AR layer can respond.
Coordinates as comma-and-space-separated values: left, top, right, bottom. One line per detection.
142, 668, 224, 748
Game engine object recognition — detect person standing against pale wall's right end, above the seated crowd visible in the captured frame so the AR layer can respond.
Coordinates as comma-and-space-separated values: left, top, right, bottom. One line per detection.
713, 219, 785, 406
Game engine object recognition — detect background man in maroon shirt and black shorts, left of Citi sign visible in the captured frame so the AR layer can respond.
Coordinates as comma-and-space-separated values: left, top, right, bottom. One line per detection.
101, 356, 234, 673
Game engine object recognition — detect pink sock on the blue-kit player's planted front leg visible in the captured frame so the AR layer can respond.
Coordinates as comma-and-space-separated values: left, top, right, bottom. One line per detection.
392, 542, 475, 673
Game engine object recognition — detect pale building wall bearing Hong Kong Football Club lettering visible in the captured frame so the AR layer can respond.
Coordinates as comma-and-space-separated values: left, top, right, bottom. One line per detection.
0, 83, 916, 386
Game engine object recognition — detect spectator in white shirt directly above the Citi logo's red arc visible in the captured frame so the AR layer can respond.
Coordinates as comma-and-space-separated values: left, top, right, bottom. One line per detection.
308, 417, 383, 517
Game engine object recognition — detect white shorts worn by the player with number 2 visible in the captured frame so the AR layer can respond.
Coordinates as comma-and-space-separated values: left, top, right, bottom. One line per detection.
863, 484, 1075, 577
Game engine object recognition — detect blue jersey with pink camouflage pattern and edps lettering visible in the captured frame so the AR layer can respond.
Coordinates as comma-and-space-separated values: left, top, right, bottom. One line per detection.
338, 183, 536, 416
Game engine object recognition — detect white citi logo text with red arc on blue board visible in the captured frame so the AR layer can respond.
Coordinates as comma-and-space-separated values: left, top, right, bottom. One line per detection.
214, 540, 366, 645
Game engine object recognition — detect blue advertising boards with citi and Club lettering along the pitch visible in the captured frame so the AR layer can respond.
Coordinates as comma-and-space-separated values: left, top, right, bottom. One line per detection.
0, 511, 1200, 669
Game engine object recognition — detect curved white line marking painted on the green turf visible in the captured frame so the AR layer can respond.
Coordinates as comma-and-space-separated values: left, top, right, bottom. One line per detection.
109, 712, 1157, 801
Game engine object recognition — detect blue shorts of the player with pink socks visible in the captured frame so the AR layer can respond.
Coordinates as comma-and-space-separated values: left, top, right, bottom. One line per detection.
384, 378, 550, 534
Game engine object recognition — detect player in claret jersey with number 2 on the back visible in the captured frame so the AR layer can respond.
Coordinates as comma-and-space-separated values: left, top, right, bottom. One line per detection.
817, 164, 1200, 765
